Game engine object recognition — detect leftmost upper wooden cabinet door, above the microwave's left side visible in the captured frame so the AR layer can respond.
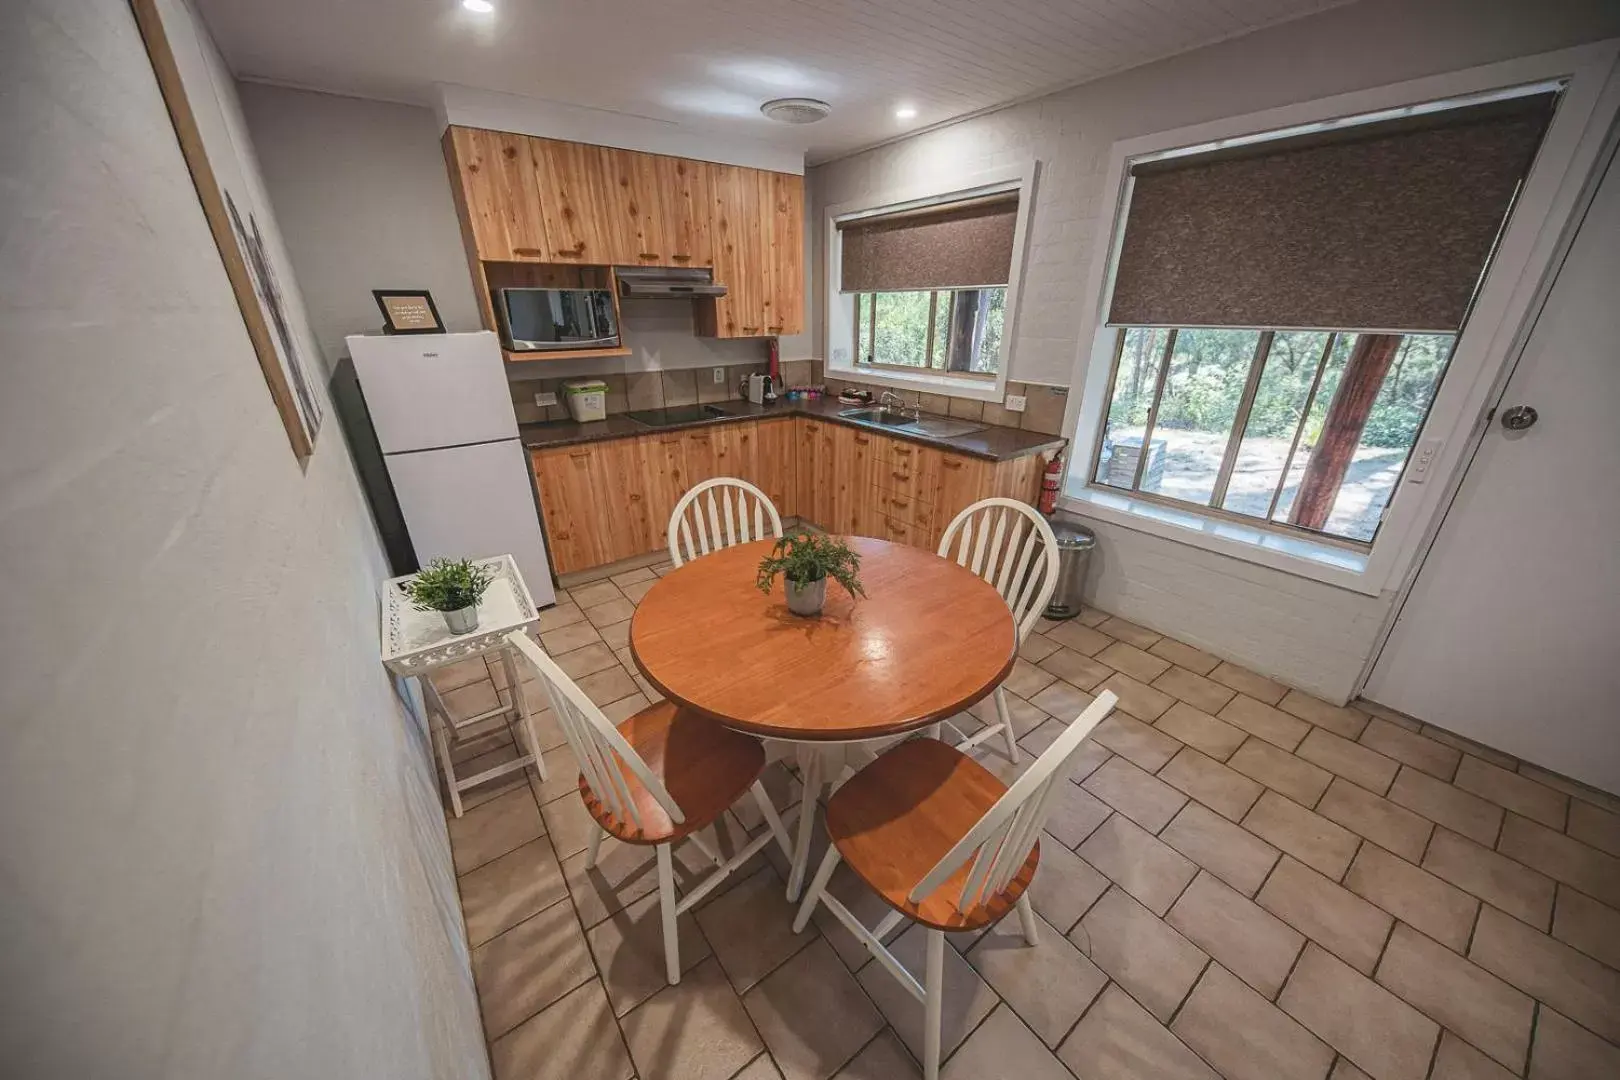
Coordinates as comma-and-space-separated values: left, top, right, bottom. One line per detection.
450, 126, 549, 262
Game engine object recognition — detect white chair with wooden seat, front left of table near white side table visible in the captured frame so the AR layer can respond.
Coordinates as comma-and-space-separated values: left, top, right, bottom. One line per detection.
507, 633, 792, 984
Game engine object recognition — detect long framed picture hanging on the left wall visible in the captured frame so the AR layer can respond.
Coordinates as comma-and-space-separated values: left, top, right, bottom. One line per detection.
130, 0, 326, 463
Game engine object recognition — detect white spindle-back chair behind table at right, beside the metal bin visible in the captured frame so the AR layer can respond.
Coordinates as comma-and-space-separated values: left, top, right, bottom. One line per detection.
940, 499, 1058, 763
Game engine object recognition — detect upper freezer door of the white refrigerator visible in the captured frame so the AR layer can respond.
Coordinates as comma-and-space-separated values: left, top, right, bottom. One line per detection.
348, 330, 517, 453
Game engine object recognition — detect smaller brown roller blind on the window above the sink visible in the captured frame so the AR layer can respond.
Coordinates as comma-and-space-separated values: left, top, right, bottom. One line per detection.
839, 194, 1017, 293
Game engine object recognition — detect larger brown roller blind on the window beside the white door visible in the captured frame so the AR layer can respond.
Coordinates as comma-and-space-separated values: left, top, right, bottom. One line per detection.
1108, 92, 1557, 332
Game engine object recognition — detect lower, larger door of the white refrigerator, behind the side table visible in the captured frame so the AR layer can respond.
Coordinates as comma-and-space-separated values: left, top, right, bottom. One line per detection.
387, 439, 557, 607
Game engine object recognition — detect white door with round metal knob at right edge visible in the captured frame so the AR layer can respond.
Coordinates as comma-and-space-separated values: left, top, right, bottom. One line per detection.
1364, 143, 1620, 792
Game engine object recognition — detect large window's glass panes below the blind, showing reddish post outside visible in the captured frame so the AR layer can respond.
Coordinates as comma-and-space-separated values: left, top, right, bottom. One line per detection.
1092, 327, 1455, 544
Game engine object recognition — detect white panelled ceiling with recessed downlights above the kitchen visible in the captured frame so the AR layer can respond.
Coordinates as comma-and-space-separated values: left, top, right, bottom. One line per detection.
196, 0, 1345, 162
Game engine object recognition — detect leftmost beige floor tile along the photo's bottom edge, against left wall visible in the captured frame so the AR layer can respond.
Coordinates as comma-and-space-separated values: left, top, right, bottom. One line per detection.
489, 980, 635, 1080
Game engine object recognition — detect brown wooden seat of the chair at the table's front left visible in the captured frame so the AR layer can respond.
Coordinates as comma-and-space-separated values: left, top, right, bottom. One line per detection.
580, 701, 765, 844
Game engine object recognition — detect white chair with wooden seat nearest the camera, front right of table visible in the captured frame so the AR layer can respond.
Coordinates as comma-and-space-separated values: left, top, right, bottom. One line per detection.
794, 691, 1118, 1080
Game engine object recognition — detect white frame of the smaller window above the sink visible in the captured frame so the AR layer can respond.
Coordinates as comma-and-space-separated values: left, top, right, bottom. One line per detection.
821, 159, 1038, 405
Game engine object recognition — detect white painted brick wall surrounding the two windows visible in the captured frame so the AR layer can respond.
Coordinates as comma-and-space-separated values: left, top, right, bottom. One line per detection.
808, 0, 1620, 699
